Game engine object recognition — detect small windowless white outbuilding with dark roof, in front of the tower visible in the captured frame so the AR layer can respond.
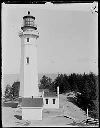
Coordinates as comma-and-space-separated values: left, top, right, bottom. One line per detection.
22, 98, 43, 120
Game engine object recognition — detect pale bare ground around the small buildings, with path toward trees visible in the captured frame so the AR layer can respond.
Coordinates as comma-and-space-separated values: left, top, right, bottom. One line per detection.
2, 95, 99, 127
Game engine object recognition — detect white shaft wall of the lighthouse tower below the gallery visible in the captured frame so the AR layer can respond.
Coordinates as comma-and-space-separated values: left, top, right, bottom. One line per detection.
20, 31, 39, 97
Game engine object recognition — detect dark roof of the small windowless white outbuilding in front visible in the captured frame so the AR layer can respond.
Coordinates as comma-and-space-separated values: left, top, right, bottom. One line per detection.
22, 98, 43, 107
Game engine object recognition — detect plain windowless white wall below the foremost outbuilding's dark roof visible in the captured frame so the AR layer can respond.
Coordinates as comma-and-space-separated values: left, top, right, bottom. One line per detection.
22, 108, 42, 120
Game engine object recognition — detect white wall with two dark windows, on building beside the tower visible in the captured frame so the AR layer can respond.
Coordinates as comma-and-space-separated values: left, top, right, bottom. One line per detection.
43, 97, 59, 109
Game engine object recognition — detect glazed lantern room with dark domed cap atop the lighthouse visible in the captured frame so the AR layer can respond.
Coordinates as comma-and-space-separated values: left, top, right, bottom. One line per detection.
21, 11, 37, 31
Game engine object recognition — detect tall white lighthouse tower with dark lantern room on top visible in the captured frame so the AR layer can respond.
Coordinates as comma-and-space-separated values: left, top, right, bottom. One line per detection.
19, 11, 39, 98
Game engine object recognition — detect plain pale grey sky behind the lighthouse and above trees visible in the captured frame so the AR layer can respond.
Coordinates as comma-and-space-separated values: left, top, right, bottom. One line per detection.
2, 4, 98, 74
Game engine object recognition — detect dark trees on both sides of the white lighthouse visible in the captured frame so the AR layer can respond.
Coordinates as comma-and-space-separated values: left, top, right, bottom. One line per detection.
5, 72, 99, 118
